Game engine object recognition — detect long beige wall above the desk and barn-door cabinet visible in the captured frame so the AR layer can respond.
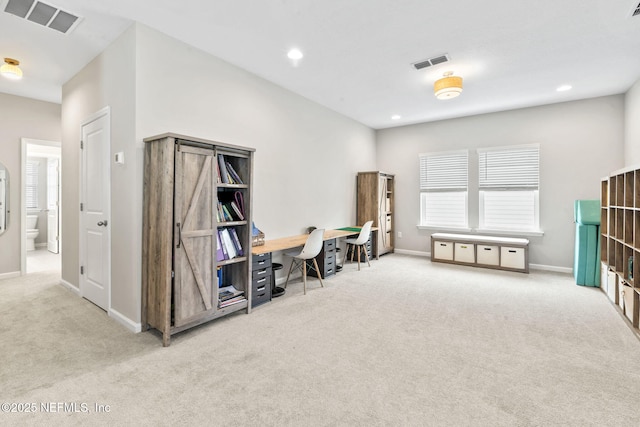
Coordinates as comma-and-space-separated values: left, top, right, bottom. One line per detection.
137, 26, 376, 238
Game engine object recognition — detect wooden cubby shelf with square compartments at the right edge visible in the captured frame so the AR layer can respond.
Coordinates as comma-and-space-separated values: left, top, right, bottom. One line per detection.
600, 168, 640, 333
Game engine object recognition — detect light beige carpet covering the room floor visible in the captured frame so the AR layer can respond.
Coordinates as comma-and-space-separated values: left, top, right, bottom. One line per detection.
0, 255, 640, 426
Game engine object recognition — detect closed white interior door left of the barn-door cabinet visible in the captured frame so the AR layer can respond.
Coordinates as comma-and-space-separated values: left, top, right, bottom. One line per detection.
80, 109, 111, 310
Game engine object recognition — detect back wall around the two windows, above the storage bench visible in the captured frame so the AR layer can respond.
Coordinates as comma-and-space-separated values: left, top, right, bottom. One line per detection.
377, 95, 624, 268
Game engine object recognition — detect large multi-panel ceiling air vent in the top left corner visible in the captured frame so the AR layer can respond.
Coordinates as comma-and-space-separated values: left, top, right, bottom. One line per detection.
4, 0, 80, 34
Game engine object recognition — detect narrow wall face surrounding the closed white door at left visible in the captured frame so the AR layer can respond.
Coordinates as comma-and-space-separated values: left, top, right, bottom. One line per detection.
62, 22, 140, 319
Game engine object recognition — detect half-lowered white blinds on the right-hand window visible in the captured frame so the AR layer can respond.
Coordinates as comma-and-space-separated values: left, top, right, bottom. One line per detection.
478, 145, 540, 190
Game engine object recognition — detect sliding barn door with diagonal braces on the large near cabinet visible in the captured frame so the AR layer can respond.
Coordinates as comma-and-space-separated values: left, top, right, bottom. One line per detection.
173, 145, 218, 327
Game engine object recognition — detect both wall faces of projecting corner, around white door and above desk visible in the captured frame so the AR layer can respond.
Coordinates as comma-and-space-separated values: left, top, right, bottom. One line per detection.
62, 24, 376, 323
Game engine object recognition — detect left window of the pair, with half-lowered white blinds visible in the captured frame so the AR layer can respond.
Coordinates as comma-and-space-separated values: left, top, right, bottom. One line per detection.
419, 150, 469, 228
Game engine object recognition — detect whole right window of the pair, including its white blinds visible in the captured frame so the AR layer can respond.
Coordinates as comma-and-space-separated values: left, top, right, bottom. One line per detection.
478, 145, 540, 231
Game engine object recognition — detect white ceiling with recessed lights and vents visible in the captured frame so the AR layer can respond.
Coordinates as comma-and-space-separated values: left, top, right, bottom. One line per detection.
0, 0, 640, 129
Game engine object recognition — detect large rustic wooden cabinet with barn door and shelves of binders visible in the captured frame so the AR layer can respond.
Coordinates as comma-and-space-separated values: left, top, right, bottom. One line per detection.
142, 133, 254, 346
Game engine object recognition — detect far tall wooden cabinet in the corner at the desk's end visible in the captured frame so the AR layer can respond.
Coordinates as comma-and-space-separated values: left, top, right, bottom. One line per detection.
356, 171, 394, 255
